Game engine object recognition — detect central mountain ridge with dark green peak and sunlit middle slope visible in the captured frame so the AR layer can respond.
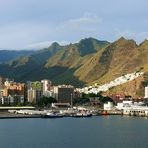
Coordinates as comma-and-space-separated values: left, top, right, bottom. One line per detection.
45, 38, 109, 86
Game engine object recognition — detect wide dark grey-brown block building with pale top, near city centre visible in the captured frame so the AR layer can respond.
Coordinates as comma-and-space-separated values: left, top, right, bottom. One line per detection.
53, 85, 74, 103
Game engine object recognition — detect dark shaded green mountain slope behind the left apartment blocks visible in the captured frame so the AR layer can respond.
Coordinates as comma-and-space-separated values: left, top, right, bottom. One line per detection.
0, 43, 62, 82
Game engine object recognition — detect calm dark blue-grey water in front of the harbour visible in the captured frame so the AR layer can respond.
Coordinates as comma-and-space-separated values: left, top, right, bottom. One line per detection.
0, 116, 148, 148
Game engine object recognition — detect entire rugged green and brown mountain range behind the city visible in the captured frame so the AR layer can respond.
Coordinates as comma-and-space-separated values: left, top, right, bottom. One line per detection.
0, 37, 148, 96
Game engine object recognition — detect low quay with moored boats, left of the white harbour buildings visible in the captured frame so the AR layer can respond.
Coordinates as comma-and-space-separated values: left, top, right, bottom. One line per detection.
0, 107, 115, 119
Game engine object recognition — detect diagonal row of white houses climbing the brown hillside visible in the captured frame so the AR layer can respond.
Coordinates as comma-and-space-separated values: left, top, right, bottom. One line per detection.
79, 72, 143, 94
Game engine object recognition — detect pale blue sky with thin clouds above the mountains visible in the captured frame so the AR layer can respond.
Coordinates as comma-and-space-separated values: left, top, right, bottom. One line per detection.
0, 0, 148, 49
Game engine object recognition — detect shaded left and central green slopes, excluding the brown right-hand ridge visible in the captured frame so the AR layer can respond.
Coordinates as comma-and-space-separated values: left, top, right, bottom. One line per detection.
0, 38, 109, 86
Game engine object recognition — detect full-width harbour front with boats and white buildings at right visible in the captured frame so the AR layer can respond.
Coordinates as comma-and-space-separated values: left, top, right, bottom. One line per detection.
0, 101, 148, 119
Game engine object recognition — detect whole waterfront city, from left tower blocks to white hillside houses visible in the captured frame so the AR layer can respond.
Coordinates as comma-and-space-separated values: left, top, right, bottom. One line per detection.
0, 72, 148, 118
